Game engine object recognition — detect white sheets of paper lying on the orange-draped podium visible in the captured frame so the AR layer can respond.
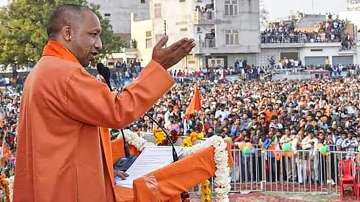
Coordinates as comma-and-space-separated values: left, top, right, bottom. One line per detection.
115, 146, 181, 188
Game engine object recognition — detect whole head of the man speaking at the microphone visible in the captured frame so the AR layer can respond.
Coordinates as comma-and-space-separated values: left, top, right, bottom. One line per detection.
47, 4, 102, 67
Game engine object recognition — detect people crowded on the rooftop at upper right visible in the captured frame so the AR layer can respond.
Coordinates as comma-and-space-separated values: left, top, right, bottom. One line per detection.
261, 17, 354, 49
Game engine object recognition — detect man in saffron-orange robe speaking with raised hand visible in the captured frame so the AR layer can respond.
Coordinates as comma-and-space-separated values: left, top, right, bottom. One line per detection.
14, 5, 195, 202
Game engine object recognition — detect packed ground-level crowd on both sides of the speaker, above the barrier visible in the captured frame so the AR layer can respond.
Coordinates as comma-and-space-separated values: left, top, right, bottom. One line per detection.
0, 65, 360, 185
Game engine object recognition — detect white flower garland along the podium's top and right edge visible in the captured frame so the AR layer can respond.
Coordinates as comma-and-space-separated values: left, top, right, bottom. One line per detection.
184, 136, 231, 202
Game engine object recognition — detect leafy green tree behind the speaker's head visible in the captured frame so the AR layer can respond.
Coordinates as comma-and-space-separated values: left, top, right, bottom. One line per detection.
0, 0, 124, 66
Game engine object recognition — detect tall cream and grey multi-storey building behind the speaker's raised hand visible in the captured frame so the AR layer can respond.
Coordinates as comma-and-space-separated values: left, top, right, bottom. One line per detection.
131, 0, 260, 70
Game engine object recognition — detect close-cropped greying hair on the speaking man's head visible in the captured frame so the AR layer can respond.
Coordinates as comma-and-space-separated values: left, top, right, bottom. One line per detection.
47, 4, 91, 39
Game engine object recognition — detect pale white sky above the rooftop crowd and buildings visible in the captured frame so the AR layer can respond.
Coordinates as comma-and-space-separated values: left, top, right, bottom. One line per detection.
0, 0, 347, 20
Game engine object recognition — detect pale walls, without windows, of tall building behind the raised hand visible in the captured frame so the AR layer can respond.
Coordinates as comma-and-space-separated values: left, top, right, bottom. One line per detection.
145, 0, 260, 69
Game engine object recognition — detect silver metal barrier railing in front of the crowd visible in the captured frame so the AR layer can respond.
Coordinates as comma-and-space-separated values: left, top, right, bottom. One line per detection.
192, 149, 360, 196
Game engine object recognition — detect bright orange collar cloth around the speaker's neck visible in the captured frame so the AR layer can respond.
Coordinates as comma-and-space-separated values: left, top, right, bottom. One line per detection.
42, 40, 79, 63
